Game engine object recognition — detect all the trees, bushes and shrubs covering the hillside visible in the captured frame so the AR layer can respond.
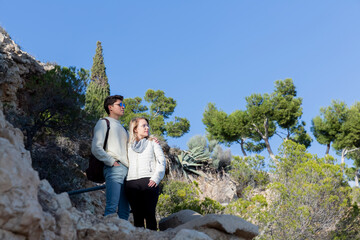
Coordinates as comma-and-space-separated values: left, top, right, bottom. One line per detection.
3, 32, 360, 239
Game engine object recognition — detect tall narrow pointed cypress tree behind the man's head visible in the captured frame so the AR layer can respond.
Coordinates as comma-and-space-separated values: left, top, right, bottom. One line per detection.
85, 41, 110, 119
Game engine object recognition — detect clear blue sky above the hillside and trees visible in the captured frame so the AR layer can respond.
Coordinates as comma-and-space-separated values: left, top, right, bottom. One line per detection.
0, 0, 360, 164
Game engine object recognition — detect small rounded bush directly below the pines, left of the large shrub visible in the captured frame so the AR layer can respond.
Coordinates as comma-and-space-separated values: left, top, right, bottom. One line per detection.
229, 154, 269, 193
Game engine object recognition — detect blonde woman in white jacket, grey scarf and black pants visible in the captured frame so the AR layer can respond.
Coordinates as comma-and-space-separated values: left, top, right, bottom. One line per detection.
125, 117, 166, 230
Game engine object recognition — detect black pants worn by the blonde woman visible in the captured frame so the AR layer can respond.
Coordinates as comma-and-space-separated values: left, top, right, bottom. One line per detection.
125, 178, 159, 230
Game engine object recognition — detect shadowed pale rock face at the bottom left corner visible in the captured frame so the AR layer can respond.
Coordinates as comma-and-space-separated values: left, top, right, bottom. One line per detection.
0, 103, 46, 239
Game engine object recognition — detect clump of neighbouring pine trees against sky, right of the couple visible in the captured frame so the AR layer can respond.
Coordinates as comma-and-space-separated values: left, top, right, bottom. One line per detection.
203, 79, 312, 160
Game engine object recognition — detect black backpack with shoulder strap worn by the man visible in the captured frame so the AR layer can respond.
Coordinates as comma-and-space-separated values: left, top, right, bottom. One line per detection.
85, 118, 110, 183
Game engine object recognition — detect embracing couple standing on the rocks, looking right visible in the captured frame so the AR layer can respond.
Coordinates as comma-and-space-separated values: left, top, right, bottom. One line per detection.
91, 95, 166, 230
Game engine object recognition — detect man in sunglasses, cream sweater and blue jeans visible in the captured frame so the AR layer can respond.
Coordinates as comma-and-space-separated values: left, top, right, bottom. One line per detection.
91, 95, 130, 220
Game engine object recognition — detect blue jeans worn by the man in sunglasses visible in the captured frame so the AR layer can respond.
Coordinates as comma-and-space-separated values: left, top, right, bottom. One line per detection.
104, 164, 130, 220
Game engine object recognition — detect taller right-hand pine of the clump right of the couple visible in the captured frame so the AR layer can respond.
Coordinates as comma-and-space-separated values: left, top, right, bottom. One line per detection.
246, 79, 311, 160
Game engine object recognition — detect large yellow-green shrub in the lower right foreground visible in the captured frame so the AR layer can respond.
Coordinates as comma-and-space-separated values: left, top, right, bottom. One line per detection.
264, 141, 350, 239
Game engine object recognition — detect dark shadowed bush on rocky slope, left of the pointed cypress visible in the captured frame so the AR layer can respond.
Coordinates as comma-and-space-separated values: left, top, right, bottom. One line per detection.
15, 66, 88, 150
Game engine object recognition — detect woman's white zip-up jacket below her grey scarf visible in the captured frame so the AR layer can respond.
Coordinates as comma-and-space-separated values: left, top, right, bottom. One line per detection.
126, 141, 166, 185
